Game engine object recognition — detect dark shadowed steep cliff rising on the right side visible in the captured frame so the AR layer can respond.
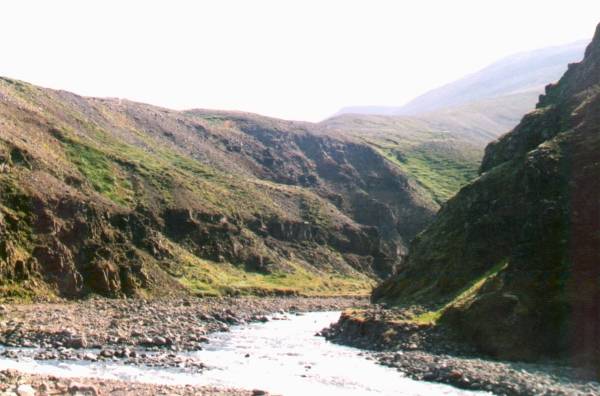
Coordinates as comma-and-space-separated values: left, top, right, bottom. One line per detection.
373, 26, 600, 365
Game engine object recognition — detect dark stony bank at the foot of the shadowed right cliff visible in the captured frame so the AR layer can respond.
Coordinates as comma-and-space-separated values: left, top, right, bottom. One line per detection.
321, 306, 600, 395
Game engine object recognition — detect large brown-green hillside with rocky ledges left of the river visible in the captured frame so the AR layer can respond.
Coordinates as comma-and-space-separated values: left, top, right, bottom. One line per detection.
0, 78, 436, 297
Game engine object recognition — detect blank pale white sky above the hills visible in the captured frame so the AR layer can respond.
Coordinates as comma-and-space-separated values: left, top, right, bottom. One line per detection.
0, 0, 600, 121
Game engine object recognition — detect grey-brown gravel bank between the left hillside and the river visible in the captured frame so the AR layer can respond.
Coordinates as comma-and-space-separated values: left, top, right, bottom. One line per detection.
0, 297, 366, 372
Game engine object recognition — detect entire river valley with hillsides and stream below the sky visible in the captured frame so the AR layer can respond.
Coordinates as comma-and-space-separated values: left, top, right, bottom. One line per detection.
0, 13, 600, 396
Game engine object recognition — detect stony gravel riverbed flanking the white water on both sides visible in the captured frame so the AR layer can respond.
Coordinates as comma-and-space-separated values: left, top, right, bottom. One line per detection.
0, 297, 600, 396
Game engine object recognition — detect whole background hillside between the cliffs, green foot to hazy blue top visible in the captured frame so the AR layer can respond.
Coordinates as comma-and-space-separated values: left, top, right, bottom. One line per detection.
319, 42, 585, 205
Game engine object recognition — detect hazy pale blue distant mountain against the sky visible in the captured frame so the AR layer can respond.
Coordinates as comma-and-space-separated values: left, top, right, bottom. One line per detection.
336, 40, 589, 116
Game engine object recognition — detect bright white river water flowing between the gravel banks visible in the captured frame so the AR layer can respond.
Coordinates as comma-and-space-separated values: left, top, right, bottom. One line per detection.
0, 312, 488, 396
